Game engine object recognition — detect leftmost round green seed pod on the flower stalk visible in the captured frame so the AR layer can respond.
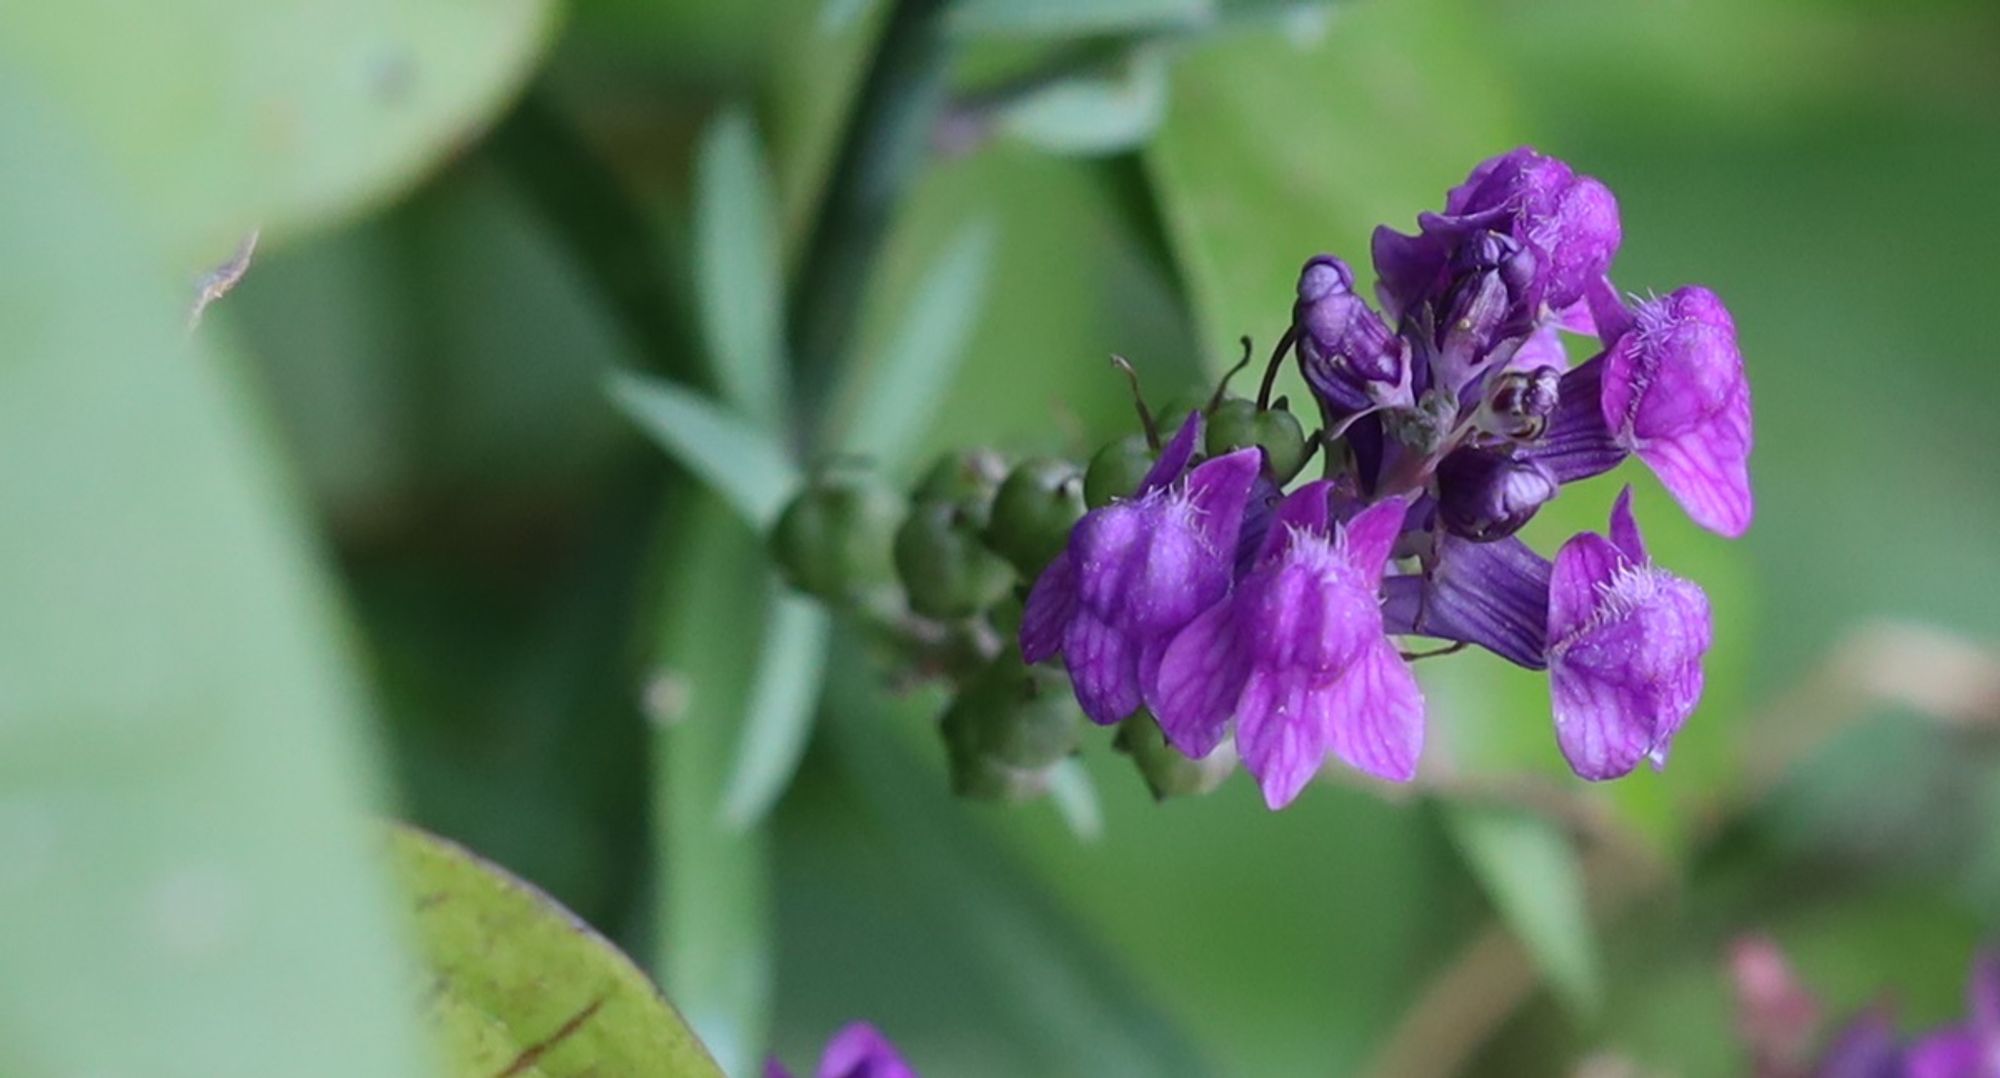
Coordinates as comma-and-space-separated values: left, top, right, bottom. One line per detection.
770, 474, 900, 602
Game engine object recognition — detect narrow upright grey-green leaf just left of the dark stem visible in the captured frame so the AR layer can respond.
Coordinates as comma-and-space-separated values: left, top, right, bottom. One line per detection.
694, 106, 786, 428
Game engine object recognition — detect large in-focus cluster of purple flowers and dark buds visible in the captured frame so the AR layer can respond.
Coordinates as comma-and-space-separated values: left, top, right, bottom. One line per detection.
1020, 148, 1752, 808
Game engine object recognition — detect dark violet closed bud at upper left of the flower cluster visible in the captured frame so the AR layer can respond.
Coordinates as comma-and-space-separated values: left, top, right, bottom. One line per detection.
1292, 254, 1408, 414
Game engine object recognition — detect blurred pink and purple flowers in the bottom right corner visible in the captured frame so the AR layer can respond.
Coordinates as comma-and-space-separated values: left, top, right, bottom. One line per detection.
1730, 936, 2000, 1078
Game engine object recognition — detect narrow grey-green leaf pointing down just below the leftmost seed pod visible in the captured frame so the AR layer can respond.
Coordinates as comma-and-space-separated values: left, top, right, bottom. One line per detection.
722, 584, 834, 830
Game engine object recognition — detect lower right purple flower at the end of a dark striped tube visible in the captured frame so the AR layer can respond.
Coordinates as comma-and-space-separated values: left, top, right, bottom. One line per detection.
1548, 488, 1710, 780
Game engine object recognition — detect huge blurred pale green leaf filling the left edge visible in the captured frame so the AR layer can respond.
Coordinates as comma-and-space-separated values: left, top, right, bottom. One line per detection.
0, 71, 422, 1078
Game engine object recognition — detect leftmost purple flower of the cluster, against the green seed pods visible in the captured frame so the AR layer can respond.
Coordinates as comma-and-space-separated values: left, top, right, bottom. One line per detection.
1020, 412, 1262, 726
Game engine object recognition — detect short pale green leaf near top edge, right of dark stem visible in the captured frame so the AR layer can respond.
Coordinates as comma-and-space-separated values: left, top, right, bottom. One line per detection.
1000, 48, 1166, 156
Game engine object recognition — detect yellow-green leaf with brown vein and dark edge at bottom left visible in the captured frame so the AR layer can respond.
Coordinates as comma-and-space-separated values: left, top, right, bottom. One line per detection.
390, 826, 722, 1078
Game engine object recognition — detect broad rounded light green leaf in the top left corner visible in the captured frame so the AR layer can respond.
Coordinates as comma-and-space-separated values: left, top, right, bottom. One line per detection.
0, 0, 554, 268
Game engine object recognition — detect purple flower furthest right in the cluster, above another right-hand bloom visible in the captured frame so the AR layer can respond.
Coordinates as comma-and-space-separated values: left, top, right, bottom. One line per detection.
1534, 286, 1754, 538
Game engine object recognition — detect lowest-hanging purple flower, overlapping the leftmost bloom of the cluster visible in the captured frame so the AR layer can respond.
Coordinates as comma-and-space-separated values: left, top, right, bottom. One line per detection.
1148, 480, 1424, 808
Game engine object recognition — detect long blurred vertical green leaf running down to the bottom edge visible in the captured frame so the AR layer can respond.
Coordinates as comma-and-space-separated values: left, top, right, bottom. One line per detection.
644, 492, 776, 1074
